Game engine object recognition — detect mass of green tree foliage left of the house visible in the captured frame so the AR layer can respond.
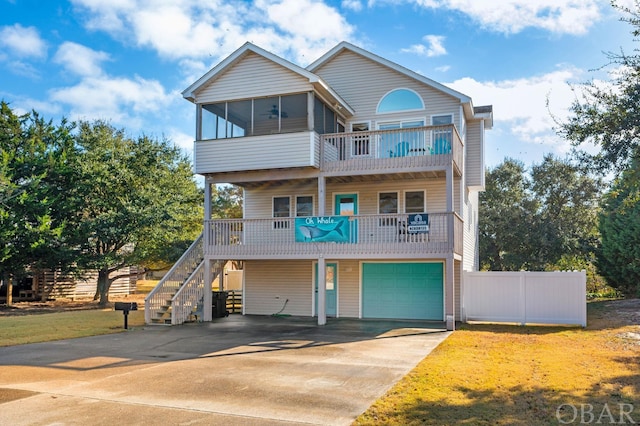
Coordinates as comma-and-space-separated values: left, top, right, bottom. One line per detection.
0, 102, 203, 304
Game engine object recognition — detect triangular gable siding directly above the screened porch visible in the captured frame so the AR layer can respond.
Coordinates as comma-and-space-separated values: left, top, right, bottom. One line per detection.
195, 53, 312, 103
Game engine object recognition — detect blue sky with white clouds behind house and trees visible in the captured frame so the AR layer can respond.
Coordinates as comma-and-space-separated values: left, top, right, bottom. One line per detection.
0, 0, 636, 168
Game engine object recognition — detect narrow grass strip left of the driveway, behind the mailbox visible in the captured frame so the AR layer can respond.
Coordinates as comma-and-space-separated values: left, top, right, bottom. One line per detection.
0, 309, 144, 346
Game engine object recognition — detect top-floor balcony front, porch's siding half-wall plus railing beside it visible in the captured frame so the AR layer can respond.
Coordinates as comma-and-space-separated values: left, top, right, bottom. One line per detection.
195, 125, 464, 181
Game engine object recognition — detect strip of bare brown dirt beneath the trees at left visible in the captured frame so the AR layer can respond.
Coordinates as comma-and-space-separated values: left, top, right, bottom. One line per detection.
0, 294, 146, 317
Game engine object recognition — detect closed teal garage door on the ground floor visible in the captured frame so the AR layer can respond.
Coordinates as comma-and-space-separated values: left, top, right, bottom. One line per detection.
362, 263, 444, 321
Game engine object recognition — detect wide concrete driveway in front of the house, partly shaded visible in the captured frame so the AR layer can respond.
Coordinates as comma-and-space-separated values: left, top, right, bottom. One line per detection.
0, 315, 449, 425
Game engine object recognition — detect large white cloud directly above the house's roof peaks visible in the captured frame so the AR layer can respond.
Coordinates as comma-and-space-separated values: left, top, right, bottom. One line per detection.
73, 0, 354, 63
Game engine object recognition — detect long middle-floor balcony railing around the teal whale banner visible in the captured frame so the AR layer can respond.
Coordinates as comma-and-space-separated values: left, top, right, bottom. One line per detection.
204, 213, 463, 259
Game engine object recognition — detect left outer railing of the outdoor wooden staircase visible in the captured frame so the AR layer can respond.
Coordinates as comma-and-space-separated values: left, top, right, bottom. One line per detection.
144, 232, 204, 324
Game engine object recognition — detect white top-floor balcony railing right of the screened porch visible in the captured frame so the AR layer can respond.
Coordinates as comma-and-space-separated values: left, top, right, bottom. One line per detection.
320, 124, 464, 172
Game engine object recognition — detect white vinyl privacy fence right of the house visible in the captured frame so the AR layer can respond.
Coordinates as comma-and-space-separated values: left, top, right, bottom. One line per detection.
462, 271, 587, 327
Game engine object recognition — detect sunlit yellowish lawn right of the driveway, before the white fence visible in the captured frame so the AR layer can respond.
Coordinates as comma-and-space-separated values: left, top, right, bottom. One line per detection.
354, 302, 640, 425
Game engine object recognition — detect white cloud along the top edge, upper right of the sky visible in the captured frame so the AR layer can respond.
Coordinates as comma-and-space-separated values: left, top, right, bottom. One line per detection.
413, 0, 609, 35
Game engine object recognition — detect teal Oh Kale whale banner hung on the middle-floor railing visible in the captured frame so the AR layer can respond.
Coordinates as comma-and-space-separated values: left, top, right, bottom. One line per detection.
295, 216, 350, 243
